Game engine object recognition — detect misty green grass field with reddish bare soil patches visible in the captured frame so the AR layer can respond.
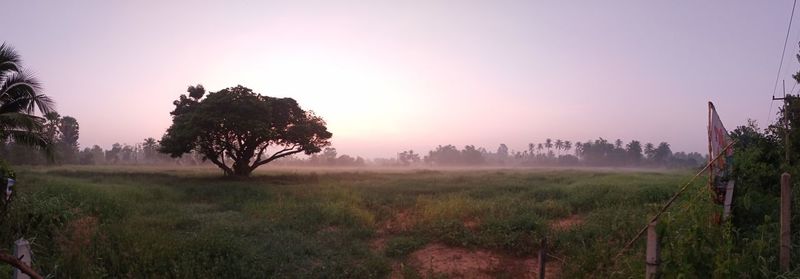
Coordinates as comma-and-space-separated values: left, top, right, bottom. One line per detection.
0, 167, 700, 278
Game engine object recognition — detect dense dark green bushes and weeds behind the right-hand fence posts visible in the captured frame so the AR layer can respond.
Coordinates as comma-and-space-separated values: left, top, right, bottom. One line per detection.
629, 117, 800, 278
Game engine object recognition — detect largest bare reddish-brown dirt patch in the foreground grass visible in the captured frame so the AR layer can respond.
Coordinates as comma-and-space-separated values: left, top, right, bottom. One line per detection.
409, 244, 561, 278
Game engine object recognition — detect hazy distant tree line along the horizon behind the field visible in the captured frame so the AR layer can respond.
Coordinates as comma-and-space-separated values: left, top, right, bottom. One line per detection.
0, 112, 707, 171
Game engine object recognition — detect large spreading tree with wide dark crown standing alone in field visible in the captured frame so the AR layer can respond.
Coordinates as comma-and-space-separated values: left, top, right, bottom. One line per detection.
159, 85, 332, 176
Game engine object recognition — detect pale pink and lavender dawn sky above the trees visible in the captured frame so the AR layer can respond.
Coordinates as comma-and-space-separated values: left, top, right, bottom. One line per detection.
0, 0, 800, 158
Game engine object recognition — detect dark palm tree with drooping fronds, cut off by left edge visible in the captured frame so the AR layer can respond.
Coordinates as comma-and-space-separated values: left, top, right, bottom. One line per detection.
0, 43, 55, 158
